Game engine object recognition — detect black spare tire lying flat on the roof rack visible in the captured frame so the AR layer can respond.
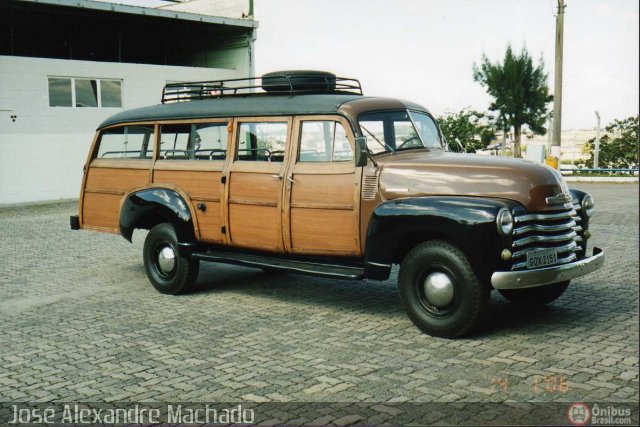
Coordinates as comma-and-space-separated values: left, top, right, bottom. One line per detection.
262, 70, 336, 92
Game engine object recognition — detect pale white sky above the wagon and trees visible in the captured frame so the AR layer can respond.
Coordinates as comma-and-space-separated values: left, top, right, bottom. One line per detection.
101, 0, 640, 129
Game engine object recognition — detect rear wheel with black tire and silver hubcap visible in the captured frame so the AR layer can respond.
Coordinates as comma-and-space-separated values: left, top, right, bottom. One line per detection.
142, 223, 200, 295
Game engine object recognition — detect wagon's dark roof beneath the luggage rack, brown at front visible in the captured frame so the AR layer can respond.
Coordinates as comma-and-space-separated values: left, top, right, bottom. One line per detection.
98, 94, 426, 129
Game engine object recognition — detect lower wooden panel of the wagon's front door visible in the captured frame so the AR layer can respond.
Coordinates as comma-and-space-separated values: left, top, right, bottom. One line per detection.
291, 208, 358, 255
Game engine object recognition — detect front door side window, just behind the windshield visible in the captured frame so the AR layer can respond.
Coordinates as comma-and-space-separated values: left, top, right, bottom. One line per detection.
298, 121, 353, 162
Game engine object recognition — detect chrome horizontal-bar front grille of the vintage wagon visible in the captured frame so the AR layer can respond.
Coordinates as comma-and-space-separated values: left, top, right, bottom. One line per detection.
511, 204, 582, 270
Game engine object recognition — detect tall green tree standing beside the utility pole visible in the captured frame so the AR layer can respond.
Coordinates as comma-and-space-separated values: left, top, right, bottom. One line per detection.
473, 46, 553, 157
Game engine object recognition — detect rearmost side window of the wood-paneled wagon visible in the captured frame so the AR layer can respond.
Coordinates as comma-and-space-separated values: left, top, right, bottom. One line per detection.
97, 126, 153, 159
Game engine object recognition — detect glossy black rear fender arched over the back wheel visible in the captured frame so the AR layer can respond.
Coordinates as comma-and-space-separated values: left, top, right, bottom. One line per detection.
120, 188, 195, 246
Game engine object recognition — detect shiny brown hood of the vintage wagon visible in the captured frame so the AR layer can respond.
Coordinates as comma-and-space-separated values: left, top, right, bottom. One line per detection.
376, 151, 569, 211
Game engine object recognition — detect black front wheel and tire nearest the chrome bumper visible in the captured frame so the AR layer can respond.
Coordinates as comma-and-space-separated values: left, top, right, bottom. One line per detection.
398, 241, 489, 338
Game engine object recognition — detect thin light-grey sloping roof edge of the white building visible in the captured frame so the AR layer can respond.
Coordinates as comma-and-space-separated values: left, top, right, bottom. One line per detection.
17, 0, 258, 28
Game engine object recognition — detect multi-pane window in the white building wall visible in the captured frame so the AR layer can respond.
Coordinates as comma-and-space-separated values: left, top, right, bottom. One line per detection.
49, 77, 122, 108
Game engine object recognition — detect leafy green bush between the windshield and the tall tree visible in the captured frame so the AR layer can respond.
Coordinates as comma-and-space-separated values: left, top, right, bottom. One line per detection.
438, 110, 495, 153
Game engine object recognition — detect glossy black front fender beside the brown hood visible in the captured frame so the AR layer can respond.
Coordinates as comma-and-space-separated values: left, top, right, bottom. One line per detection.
365, 196, 517, 283
